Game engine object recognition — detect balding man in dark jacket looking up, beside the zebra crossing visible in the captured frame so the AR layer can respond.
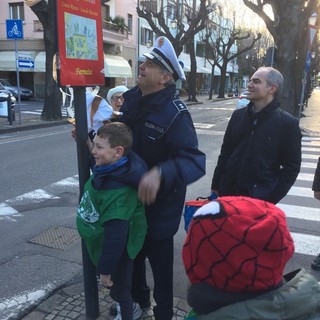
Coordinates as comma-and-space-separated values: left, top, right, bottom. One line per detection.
211, 67, 302, 203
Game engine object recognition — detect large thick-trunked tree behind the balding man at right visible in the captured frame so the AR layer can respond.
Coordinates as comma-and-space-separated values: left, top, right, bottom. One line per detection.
243, 0, 320, 116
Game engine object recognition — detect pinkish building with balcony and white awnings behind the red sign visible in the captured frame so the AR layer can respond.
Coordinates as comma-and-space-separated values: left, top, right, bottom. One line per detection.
0, 0, 138, 99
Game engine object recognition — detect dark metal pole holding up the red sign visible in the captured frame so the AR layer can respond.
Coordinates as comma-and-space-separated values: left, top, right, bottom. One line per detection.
73, 87, 99, 319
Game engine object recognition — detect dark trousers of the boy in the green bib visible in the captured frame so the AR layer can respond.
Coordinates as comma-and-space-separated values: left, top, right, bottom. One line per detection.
110, 252, 133, 320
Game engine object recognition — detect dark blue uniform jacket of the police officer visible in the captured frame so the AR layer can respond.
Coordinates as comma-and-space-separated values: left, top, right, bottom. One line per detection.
122, 85, 205, 239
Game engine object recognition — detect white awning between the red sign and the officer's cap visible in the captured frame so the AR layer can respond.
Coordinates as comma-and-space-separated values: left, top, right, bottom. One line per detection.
104, 54, 132, 78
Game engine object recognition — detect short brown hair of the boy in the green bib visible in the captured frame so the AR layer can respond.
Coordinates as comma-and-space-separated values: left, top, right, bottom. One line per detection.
97, 122, 132, 156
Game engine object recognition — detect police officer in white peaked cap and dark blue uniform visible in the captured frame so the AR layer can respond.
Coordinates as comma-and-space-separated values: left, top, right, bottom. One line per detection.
121, 36, 205, 320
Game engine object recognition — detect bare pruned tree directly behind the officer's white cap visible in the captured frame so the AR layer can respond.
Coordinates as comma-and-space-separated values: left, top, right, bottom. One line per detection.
137, 0, 214, 101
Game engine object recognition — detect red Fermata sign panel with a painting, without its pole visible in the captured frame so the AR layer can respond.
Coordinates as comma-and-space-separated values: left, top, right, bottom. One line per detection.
57, 0, 104, 87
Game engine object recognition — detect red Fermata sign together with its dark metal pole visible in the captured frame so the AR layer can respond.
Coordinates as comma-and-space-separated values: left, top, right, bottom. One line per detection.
56, 0, 105, 319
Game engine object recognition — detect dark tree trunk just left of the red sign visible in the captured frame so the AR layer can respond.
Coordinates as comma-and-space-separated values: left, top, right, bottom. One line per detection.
25, 0, 62, 121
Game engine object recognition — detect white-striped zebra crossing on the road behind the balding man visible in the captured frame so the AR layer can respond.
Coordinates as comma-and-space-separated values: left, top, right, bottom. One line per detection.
278, 137, 320, 256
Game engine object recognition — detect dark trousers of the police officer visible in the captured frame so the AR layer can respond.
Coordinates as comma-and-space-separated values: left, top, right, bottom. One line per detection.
132, 238, 173, 320
